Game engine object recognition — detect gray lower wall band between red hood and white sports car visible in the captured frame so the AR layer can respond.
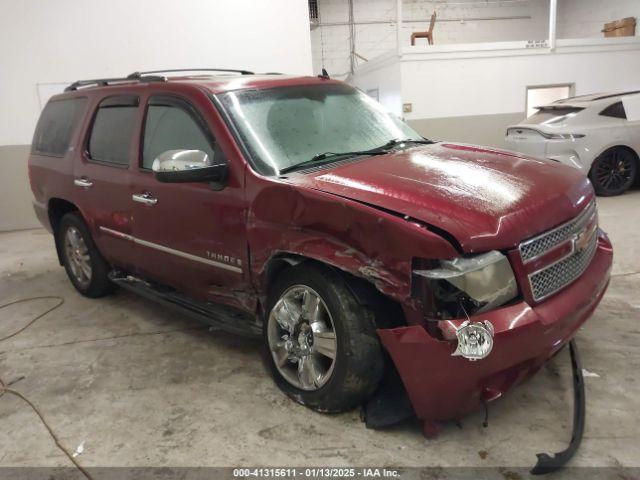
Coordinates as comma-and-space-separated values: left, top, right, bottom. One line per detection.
407, 112, 526, 148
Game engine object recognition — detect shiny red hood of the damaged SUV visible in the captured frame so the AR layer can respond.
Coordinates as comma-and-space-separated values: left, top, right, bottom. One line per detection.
288, 143, 593, 252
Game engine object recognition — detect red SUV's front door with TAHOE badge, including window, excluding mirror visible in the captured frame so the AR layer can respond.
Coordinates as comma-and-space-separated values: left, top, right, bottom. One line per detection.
132, 96, 248, 309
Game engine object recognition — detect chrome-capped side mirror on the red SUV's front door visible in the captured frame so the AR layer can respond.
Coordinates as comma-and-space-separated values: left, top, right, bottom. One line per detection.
151, 150, 229, 183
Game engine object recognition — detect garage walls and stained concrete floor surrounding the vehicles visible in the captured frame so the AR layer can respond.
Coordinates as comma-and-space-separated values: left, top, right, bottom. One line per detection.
0, 0, 640, 479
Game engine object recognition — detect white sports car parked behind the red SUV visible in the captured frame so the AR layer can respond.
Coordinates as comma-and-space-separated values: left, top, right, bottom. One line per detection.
506, 91, 640, 196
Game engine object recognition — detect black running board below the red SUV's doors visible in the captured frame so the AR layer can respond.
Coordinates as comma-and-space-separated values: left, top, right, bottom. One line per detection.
109, 270, 262, 337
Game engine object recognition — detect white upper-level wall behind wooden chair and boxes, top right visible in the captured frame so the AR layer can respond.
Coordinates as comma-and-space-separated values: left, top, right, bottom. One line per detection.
311, 0, 640, 77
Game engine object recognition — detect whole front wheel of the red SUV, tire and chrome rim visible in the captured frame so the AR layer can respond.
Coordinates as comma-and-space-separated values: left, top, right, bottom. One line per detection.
263, 263, 384, 412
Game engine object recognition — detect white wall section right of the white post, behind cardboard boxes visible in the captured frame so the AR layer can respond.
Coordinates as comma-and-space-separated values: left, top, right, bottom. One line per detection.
558, 0, 640, 38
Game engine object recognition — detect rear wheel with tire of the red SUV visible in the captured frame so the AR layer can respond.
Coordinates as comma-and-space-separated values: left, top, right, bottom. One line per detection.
56, 212, 113, 298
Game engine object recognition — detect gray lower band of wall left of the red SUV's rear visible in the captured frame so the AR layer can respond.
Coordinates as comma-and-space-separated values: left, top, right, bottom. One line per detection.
0, 145, 40, 231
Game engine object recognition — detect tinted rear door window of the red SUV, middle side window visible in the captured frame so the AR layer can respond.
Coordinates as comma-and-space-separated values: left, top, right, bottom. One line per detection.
88, 95, 139, 165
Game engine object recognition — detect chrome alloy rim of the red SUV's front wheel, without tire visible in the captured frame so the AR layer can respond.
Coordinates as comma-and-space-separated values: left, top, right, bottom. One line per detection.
267, 285, 338, 390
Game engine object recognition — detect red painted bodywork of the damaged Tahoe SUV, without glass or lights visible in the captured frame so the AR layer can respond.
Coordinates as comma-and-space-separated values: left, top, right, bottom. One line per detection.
29, 76, 611, 420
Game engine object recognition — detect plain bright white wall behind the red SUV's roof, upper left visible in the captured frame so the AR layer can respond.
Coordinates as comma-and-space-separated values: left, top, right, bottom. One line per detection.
0, 0, 311, 145
